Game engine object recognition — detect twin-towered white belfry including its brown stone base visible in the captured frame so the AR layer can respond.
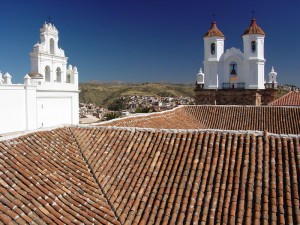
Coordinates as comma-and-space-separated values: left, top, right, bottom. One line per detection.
195, 18, 277, 105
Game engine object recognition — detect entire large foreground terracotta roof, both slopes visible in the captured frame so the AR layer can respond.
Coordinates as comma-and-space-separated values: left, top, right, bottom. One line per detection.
0, 127, 300, 224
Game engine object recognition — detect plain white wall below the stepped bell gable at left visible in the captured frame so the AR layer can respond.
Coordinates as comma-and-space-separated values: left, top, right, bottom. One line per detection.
0, 84, 79, 134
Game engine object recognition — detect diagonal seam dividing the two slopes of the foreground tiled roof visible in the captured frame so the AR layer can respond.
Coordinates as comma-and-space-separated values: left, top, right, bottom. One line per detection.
68, 126, 123, 224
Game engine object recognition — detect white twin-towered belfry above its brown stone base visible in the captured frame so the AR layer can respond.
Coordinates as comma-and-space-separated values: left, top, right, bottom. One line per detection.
197, 19, 276, 89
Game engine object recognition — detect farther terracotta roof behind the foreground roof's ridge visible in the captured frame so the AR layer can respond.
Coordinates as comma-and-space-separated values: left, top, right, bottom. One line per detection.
105, 105, 300, 134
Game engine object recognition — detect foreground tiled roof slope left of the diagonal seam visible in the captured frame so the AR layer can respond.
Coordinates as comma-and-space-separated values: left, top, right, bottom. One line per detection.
0, 128, 120, 224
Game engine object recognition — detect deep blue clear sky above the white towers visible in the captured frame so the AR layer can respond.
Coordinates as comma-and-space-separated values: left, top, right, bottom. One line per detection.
0, 0, 300, 86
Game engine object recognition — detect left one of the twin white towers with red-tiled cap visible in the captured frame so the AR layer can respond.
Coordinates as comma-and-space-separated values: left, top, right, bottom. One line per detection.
203, 22, 225, 89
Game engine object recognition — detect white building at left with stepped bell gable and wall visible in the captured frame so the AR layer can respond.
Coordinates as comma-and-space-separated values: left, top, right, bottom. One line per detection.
0, 23, 79, 135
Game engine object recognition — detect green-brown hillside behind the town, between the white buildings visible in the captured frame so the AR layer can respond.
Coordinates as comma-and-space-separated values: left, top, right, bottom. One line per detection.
79, 82, 194, 107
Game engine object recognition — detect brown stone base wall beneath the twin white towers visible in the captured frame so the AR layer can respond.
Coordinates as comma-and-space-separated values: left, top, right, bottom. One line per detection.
194, 89, 276, 105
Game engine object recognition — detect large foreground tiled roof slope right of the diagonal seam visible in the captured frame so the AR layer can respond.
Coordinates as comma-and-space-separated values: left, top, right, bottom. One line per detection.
72, 128, 300, 224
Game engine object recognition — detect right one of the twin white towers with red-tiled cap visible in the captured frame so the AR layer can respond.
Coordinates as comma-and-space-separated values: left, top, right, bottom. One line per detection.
243, 18, 266, 89
